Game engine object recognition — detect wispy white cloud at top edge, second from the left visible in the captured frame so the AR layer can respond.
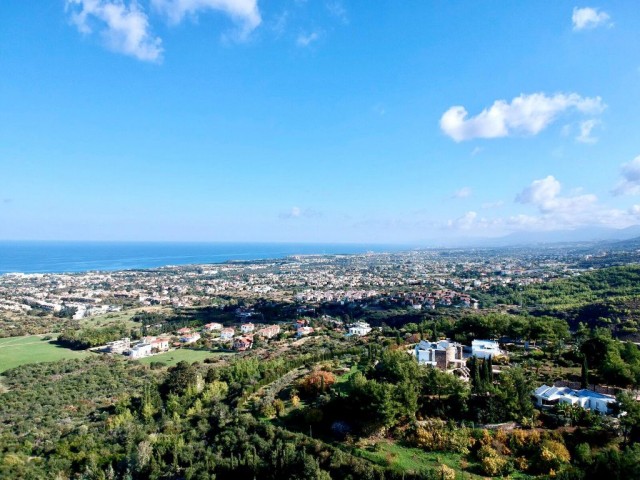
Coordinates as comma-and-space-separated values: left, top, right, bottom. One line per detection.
151, 0, 262, 37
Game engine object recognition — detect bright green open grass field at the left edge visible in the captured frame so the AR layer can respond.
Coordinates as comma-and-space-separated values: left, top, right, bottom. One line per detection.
0, 335, 91, 373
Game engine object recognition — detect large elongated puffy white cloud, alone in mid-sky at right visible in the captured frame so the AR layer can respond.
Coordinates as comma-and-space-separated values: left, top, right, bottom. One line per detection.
440, 93, 606, 142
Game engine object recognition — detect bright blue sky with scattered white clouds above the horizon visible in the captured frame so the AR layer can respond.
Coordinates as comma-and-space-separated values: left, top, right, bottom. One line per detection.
0, 0, 640, 243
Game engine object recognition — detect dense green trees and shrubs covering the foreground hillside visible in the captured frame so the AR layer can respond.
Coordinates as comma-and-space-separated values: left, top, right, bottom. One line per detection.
0, 267, 640, 480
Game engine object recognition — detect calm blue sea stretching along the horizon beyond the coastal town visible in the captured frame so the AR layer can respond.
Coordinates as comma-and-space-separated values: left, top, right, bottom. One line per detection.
0, 241, 401, 274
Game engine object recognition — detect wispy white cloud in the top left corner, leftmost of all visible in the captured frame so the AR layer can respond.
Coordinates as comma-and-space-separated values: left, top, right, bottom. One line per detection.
66, 0, 162, 62
